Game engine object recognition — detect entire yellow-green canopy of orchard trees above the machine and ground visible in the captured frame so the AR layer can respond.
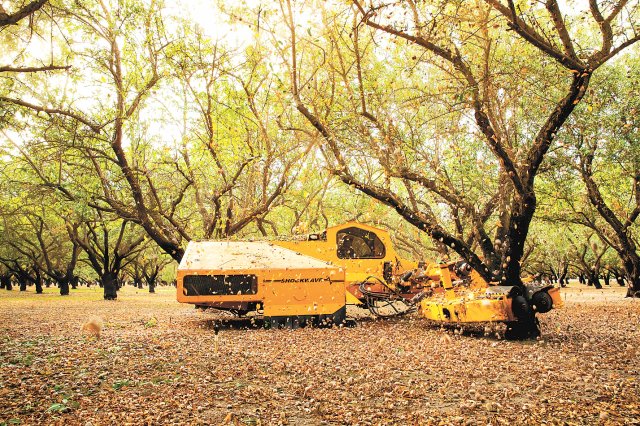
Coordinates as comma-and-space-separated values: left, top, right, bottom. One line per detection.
0, 0, 640, 294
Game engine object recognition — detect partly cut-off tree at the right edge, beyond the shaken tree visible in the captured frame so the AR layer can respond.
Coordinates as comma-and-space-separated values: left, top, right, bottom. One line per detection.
557, 60, 640, 296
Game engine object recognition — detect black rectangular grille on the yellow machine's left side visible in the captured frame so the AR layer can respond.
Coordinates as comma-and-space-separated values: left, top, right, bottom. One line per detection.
182, 275, 258, 296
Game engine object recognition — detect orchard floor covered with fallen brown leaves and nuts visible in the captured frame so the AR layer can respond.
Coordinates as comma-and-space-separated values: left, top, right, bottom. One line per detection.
0, 286, 640, 425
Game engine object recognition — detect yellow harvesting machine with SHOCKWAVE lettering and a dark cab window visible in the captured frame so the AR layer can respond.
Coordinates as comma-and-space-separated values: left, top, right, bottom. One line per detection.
177, 222, 562, 338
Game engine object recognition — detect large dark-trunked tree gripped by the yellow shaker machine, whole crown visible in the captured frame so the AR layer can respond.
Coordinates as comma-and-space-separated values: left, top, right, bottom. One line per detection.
282, 0, 639, 285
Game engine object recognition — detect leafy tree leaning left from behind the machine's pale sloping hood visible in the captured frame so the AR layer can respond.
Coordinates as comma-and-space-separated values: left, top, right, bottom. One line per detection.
0, 2, 311, 261
